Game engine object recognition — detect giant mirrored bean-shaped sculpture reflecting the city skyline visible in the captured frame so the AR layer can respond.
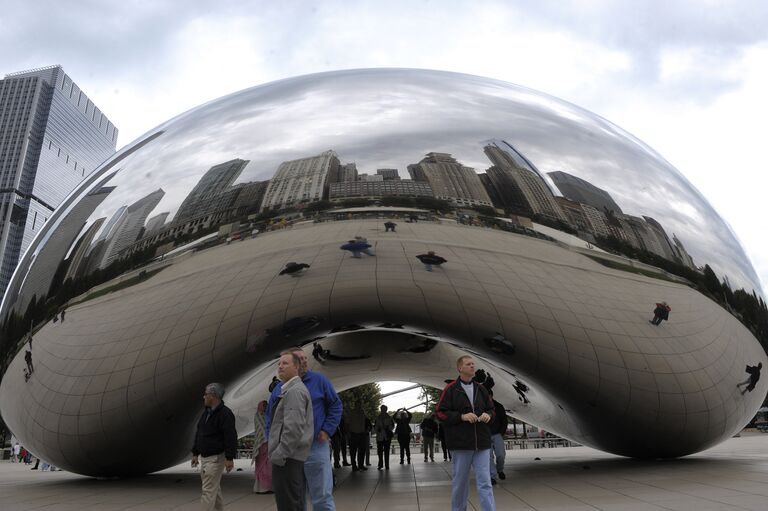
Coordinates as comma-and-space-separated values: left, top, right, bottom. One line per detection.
0, 69, 768, 475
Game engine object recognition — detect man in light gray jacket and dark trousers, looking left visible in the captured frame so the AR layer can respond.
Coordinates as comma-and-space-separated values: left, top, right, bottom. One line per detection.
268, 351, 315, 511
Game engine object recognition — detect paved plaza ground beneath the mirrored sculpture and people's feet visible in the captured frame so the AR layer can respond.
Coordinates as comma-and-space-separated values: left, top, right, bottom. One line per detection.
0, 434, 768, 511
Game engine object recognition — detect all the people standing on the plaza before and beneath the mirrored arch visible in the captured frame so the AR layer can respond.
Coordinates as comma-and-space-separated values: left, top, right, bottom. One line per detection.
192, 347, 507, 511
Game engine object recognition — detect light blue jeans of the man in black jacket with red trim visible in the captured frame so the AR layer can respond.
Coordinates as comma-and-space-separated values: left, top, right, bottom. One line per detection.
451, 449, 496, 511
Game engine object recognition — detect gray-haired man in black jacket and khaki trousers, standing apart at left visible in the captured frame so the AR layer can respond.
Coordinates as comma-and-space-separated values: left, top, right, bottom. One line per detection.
192, 383, 237, 511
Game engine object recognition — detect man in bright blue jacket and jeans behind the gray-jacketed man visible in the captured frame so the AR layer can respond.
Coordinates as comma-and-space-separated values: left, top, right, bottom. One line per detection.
266, 347, 342, 511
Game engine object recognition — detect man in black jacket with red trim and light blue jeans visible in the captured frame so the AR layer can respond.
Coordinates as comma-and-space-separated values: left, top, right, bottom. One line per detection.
437, 355, 496, 511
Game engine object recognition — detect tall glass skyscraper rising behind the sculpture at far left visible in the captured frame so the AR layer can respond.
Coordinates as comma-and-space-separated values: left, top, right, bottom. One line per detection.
0, 66, 118, 296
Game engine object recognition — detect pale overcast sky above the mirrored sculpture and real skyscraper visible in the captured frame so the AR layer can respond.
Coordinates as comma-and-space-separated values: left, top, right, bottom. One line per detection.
0, 0, 768, 408
